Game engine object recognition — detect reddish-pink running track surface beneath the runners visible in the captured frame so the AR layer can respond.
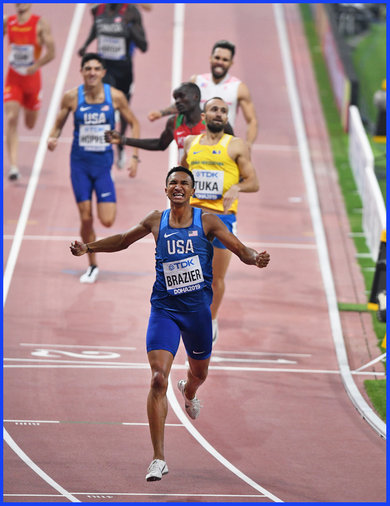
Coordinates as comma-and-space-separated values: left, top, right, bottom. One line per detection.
4, 4, 386, 502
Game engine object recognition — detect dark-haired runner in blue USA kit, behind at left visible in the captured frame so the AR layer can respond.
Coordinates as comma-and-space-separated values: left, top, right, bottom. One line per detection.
47, 53, 139, 283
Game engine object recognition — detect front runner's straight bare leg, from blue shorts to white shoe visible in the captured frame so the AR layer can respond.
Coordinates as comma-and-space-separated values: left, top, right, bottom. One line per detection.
147, 350, 174, 460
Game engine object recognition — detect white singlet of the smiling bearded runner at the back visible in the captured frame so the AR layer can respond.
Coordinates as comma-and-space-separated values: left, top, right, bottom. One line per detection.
195, 73, 241, 127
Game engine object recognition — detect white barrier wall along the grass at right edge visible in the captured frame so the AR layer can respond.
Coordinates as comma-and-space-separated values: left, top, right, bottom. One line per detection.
349, 105, 386, 262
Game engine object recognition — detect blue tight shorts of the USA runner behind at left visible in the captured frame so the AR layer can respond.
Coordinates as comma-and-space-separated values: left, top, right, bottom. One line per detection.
70, 153, 116, 203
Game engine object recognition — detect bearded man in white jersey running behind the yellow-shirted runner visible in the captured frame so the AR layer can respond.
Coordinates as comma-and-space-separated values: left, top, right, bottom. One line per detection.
148, 40, 257, 147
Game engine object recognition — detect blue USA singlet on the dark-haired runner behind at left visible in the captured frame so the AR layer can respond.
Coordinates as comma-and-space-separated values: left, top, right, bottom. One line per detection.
72, 84, 115, 158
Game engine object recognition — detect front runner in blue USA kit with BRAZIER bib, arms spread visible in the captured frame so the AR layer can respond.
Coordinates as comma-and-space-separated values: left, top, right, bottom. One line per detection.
70, 166, 270, 481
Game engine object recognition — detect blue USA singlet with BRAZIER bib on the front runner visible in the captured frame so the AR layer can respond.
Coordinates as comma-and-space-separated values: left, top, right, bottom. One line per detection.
150, 208, 213, 311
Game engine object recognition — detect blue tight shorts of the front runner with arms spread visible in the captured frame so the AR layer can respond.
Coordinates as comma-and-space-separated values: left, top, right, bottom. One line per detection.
146, 306, 213, 360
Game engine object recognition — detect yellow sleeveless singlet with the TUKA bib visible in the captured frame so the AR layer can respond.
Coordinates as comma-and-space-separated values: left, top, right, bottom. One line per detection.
187, 134, 240, 214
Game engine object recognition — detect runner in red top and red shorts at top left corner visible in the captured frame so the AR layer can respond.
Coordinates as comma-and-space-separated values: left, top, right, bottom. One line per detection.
3, 4, 55, 180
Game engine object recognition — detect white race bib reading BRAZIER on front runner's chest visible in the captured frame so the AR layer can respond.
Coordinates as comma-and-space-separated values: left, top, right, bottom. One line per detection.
163, 255, 204, 295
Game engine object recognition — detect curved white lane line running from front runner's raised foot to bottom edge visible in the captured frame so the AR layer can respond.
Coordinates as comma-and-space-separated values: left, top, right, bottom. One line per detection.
167, 376, 283, 502
